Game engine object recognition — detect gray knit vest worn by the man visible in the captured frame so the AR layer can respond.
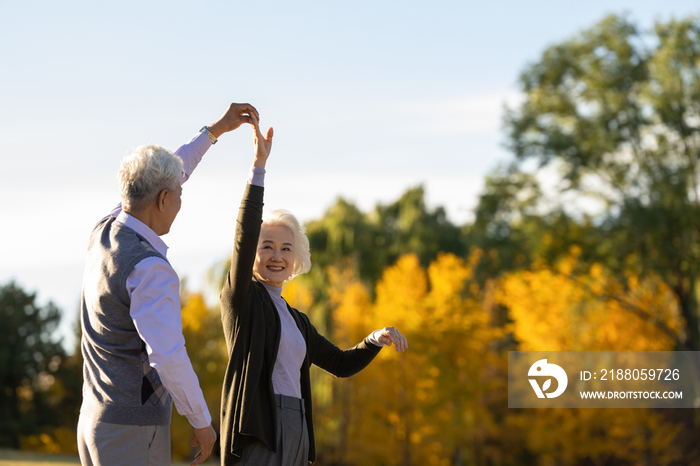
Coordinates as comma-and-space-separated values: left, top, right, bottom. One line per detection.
80, 217, 172, 426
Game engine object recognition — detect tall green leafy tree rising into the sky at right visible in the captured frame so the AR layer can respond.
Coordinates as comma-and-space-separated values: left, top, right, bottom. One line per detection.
506, 15, 700, 351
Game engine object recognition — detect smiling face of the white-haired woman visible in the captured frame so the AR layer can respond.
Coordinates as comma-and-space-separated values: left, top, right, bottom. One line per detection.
253, 225, 294, 288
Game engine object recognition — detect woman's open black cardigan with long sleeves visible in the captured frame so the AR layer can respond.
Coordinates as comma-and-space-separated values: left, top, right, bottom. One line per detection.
221, 185, 381, 465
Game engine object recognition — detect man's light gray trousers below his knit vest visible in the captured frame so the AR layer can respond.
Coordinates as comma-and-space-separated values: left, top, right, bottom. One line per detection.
78, 414, 170, 466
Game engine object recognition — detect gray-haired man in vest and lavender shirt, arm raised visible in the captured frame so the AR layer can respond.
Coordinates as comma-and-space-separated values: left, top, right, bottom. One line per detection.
78, 104, 259, 466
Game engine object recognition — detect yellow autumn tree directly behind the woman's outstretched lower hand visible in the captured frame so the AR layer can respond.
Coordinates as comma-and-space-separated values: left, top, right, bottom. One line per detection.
328, 255, 504, 465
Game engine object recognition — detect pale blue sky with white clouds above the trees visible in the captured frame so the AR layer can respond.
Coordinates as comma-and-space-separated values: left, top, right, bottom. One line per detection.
0, 0, 700, 345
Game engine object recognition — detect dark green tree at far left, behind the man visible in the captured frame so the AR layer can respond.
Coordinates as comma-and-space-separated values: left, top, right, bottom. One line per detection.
0, 282, 65, 448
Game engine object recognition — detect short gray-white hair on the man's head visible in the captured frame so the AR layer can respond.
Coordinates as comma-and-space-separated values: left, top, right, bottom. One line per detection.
119, 145, 182, 212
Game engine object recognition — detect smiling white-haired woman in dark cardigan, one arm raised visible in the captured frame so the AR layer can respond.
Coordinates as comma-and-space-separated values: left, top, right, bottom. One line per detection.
221, 117, 407, 466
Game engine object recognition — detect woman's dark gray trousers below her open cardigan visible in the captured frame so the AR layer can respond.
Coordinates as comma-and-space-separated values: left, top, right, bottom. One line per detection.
241, 395, 309, 466
